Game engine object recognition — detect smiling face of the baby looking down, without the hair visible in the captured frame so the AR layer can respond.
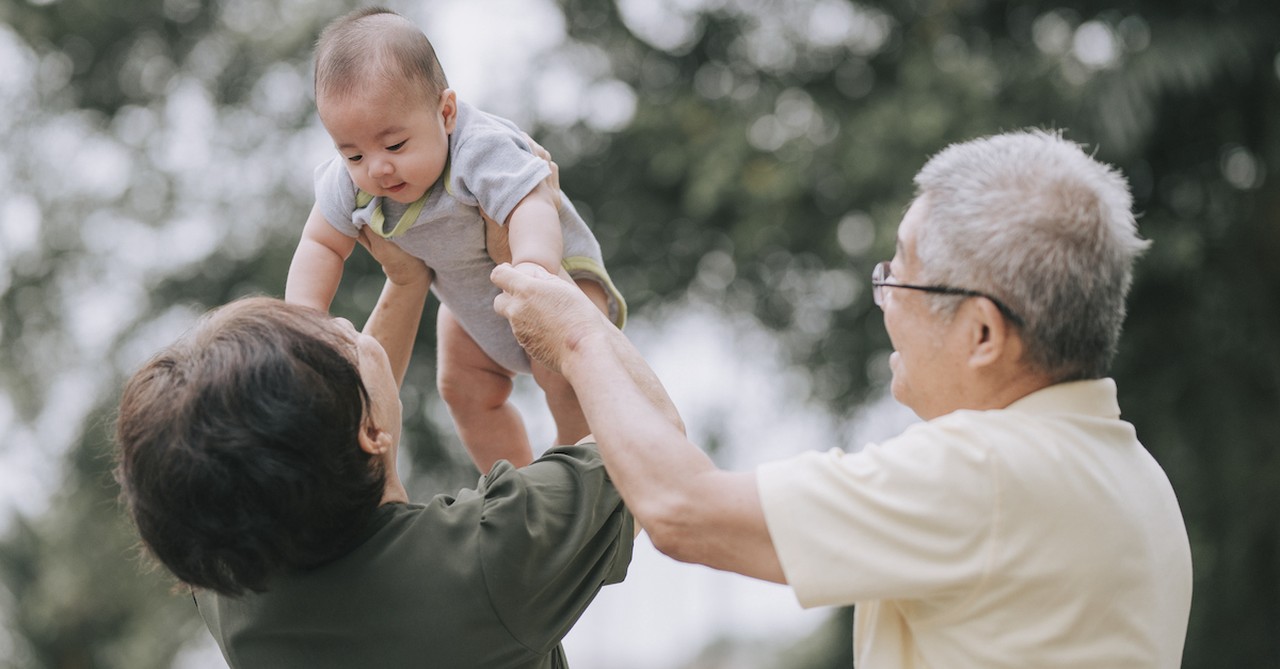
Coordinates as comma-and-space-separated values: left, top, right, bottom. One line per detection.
317, 90, 458, 205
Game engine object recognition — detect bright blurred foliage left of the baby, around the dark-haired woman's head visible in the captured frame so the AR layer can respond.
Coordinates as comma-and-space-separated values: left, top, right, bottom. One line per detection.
0, 0, 474, 668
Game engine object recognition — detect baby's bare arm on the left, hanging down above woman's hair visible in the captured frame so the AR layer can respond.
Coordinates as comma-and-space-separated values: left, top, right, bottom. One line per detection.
284, 206, 356, 311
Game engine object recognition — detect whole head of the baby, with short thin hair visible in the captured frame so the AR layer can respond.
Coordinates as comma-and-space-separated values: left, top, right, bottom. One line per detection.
315, 8, 458, 205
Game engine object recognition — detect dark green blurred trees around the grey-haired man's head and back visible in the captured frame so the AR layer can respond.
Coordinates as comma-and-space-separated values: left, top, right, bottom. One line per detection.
549, 0, 1280, 666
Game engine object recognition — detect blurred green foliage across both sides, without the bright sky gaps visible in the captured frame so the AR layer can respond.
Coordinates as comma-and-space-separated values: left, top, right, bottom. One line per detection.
0, 0, 1280, 669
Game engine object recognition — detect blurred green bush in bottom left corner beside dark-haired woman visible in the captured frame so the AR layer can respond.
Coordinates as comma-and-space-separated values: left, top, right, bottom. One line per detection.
0, 406, 200, 669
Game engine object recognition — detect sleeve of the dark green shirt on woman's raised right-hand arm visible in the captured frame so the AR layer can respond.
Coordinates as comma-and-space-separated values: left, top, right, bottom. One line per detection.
480, 444, 635, 652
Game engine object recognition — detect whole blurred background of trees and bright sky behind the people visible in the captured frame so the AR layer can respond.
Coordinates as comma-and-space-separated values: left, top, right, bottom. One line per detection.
0, 0, 1280, 669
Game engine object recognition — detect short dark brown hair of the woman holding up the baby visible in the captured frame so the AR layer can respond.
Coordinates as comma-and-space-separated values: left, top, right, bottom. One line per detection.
115, 298, 385, 595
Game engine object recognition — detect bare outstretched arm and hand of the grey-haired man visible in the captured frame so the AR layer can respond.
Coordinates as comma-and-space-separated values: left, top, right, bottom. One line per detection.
492, 265, 785, 582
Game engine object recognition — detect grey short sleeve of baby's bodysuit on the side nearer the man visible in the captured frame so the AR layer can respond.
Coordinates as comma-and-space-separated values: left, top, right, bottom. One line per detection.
449, 129, 552, 225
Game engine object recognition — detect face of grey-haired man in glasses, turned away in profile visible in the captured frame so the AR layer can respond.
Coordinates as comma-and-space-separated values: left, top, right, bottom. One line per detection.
882, 197, 965, 420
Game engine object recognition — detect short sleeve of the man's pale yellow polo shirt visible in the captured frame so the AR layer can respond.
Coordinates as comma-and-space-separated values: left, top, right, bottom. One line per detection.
756, 423, 1000, 608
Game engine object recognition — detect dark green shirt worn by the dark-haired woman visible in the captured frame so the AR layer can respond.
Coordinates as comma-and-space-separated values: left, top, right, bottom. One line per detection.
196, 445, 635, 669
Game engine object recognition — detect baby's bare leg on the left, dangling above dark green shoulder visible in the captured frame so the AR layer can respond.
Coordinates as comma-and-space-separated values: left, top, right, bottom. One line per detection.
435, 304, 534, 472
